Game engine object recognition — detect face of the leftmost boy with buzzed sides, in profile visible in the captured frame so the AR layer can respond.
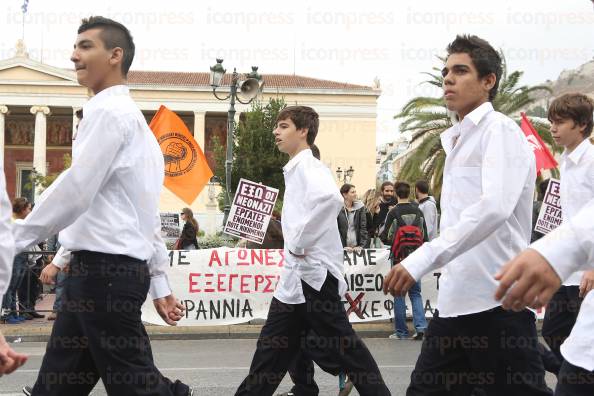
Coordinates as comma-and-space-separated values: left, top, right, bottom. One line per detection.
70, 28, 122, 93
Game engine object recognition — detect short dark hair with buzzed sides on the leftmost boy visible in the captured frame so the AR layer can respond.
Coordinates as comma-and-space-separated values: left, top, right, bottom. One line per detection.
78, 16, 136, 77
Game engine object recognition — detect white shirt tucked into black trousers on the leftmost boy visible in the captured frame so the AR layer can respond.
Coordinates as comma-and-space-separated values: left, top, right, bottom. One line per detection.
14, 85, 171, 298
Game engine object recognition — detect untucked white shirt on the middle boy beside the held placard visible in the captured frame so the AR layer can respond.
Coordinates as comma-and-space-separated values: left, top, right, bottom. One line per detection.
274, 149, 347, 304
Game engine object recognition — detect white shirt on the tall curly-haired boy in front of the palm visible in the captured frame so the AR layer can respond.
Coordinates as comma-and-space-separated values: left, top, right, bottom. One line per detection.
402, 102, 536, 317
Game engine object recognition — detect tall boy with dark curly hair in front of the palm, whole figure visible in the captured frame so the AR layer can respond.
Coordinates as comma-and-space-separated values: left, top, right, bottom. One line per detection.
384, 36, 551, 396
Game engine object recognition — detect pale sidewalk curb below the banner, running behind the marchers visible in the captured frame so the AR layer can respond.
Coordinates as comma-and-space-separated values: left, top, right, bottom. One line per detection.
0, 322, 394, 343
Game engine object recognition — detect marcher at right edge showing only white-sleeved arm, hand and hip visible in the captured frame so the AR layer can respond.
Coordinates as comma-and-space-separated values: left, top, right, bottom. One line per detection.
495, 199, 594, 396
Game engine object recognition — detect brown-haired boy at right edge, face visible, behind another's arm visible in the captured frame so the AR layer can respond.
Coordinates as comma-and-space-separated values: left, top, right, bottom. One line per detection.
542, 93, 594, 362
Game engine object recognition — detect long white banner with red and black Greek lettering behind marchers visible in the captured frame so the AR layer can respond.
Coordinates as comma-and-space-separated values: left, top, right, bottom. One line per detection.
142, 248, 444, 326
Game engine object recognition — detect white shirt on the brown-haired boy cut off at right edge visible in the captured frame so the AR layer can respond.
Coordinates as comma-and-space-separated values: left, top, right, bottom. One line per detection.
561, 139, 594, 286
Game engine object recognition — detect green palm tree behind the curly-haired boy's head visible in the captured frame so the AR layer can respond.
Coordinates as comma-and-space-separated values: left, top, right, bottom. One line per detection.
394, 54, 561, 198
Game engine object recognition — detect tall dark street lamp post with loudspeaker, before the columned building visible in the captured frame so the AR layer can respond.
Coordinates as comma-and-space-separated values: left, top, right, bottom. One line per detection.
210, 59, 264, 226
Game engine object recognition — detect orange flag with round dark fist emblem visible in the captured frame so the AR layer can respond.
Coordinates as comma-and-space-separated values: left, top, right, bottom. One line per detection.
149, 106, 213, 205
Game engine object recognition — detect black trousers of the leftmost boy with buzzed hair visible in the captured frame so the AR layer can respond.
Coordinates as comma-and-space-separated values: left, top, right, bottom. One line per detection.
33, 252, 189, 396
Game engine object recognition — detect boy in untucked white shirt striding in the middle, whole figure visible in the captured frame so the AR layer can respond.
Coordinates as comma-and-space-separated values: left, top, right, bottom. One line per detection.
235, 106, 390, 396
